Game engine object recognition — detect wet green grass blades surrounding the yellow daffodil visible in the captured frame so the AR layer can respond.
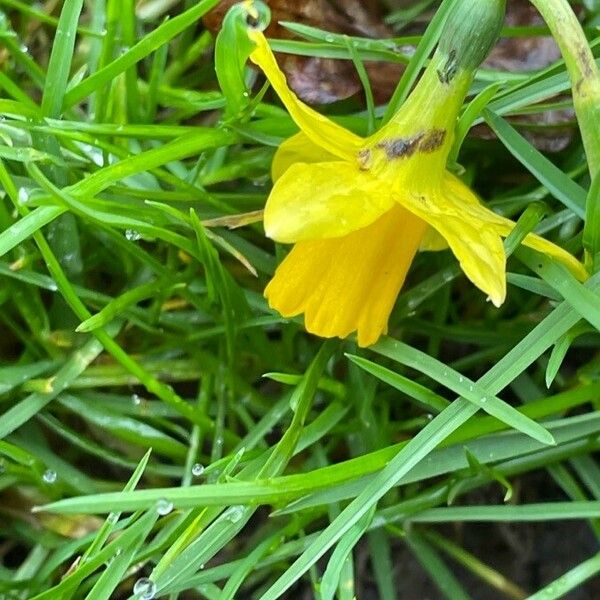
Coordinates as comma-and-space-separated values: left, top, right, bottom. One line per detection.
0, 0, 600, 600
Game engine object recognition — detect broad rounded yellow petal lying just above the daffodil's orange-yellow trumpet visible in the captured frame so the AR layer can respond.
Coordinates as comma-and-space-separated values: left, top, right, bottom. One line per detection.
264, 161, 394, 243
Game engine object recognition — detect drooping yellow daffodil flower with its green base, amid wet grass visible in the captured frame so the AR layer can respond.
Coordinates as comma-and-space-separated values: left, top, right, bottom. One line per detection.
243, 0, 586, 346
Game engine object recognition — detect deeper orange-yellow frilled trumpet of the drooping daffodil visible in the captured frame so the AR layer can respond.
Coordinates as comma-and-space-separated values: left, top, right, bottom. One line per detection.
265, 206, 427, 346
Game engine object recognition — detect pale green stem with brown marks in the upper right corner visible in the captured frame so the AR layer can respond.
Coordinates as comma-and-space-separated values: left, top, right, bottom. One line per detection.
531, 0, 600, 177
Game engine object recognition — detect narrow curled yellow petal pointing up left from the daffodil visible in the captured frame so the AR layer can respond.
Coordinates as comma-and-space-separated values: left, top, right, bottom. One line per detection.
248, 30, 364, 161
